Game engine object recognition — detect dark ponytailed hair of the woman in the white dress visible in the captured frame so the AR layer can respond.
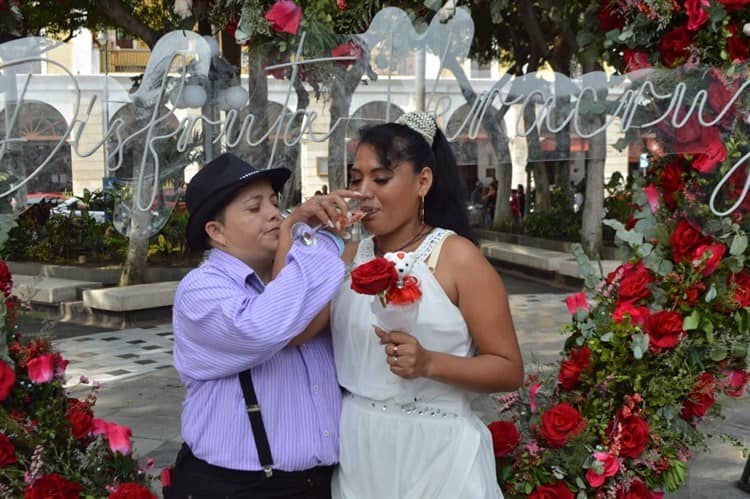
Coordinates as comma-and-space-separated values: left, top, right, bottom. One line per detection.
359, 123, 476, 242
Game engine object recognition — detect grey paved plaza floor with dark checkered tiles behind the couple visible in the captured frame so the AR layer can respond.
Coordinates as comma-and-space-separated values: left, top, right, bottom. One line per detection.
44, 292, 750, 499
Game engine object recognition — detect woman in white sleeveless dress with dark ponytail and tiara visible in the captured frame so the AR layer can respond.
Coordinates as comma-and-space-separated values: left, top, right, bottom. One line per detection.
331, 113, 523, 499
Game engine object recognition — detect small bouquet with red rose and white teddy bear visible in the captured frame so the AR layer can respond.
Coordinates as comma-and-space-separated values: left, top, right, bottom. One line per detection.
351, 251, 422, 332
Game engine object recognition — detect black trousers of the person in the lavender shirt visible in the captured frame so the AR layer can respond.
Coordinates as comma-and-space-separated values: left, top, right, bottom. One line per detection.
163, 444, 333, 499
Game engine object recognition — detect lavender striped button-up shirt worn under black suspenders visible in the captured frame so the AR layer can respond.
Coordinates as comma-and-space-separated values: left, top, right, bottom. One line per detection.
173, 236, 344, 471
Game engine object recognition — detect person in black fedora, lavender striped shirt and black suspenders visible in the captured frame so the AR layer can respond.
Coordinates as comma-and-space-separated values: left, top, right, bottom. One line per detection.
165, 154, 356, 499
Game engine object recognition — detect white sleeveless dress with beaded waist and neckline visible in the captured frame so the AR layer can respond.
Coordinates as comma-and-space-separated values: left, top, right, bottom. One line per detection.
331, 229, 502, 499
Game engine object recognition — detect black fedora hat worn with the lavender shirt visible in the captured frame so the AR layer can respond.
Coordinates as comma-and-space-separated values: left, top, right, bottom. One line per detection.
185, 153, 292, 250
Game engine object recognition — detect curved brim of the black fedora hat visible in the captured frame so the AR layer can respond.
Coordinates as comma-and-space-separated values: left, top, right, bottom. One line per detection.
187, 168, 292, 250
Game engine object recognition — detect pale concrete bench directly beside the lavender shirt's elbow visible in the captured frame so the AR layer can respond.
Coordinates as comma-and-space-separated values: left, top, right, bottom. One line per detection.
83, 281, 180, 312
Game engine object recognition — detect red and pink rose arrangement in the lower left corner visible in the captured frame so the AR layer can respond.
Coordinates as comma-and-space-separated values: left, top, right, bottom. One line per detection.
0, 261, 156, 499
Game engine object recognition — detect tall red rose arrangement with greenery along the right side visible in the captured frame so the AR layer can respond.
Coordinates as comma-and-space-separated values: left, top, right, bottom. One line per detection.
490, 36, 750, 499
